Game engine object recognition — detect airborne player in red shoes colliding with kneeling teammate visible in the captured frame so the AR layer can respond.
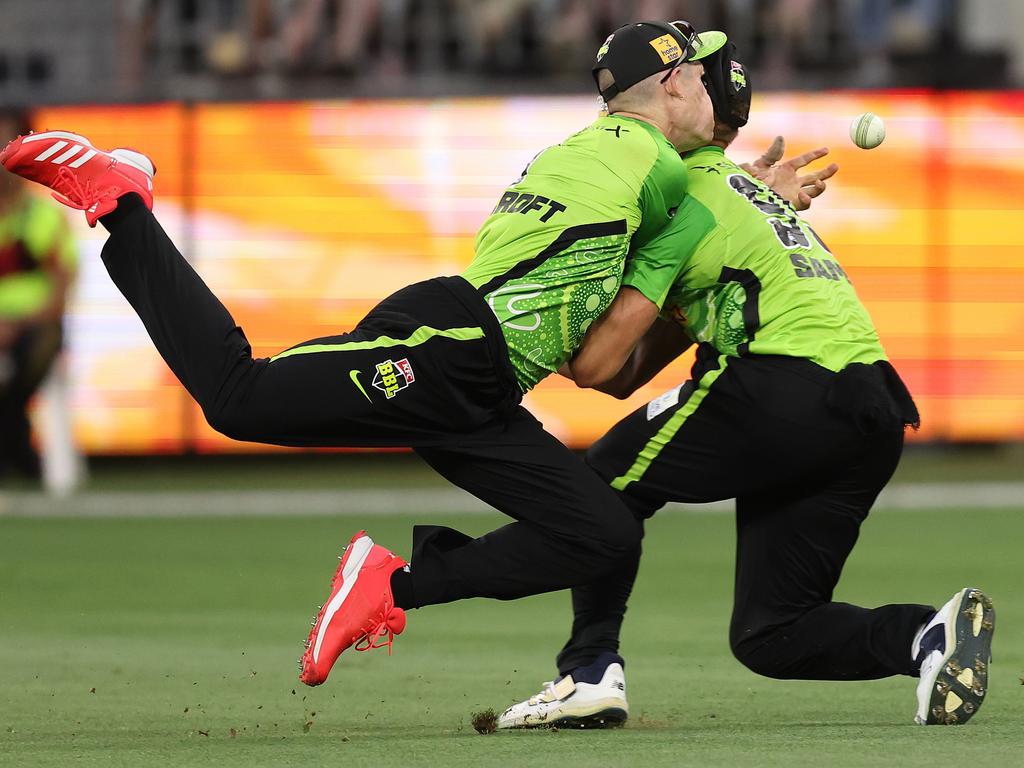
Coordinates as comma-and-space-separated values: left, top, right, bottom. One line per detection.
0, 22, 774, 685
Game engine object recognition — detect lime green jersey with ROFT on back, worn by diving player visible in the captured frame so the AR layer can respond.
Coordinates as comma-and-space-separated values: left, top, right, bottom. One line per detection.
462, 115, 686, 392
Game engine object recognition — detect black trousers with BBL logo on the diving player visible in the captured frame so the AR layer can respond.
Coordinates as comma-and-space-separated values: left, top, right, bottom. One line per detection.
96, 196, 642, 607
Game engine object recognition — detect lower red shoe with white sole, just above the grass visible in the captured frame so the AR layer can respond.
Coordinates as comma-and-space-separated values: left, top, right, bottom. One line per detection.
299, 530, 406, 685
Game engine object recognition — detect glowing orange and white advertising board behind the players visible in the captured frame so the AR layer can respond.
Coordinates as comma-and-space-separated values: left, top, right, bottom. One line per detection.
36, 92, 1024, 453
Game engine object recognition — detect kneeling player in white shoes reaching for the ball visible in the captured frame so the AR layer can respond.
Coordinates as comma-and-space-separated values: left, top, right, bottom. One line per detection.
500, 41, 994, 728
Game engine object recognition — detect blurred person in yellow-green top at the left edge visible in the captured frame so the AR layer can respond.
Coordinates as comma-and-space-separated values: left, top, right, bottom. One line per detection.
0, 111, 76, 479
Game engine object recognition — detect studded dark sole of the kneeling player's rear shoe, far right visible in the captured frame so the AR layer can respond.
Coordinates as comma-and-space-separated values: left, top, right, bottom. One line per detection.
918, 589, 995, 725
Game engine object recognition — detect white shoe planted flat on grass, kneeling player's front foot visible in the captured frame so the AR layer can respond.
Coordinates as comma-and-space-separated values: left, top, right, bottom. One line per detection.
498, 653, 630, 728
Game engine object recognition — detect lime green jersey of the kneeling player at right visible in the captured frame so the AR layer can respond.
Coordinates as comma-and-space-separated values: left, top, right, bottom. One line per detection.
624, 146, 886, 372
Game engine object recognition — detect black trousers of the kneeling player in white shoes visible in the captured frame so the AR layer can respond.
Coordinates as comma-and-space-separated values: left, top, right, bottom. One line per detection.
557, 345, 935, 680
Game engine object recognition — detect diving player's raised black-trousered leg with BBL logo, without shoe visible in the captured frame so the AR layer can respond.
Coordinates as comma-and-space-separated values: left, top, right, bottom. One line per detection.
101, 196, 516, 445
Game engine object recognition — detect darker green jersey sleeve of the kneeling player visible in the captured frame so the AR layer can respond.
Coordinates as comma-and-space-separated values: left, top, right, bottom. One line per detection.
623, 197, 715, 308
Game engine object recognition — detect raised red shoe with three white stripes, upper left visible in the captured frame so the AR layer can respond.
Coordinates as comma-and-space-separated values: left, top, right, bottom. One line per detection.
0, 131, 157, 226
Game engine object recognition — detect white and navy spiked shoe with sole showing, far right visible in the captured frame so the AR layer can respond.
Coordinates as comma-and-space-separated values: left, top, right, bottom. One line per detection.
910, 587, 995, 725
